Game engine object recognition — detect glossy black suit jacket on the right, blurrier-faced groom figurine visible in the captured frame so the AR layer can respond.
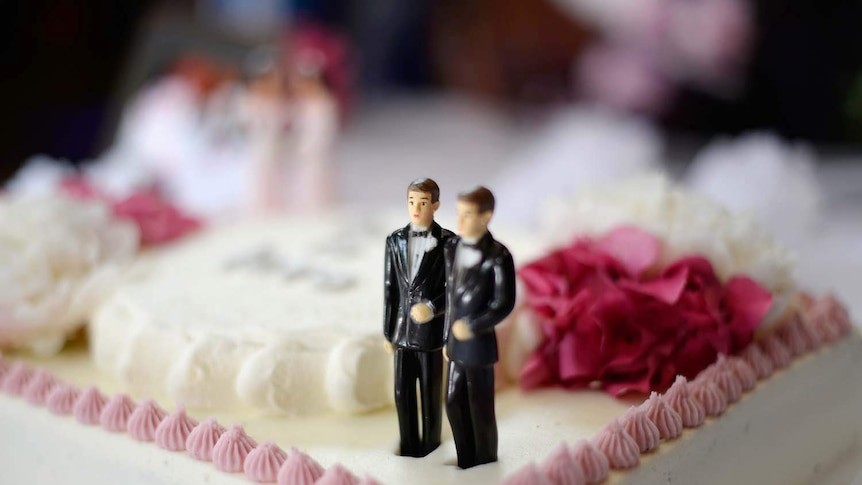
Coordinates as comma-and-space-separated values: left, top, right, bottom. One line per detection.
444, 232, 515, 366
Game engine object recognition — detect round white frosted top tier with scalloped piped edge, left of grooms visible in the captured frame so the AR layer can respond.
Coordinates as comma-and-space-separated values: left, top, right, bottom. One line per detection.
90, 217, 392, 415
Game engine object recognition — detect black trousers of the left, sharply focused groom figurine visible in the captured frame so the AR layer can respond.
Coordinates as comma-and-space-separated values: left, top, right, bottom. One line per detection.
395, 347, 443, 457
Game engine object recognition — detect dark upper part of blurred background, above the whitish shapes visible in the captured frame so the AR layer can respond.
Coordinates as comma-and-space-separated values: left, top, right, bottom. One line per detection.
0, 0, 862, 177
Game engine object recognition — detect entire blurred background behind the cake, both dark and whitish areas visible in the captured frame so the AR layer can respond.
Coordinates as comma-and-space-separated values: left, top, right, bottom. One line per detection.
0, 0, 862, 356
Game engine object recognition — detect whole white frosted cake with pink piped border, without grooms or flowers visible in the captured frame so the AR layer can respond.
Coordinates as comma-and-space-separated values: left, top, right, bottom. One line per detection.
0, 182, 862, 485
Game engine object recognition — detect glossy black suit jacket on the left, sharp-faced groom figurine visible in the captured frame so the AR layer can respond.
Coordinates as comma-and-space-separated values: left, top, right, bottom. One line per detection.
383, 222, 454, 351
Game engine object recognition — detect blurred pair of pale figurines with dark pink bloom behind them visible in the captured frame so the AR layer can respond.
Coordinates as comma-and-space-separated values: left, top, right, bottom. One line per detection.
243, 26, 345, 214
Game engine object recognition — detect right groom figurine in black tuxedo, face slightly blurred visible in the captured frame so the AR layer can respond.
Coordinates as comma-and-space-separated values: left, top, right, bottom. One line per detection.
444, 187, 515, 468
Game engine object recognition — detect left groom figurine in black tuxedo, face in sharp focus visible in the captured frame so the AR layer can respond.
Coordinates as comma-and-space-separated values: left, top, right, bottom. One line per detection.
383, 178, 454, 457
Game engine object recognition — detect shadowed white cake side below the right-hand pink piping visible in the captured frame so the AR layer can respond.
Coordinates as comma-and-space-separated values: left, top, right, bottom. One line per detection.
608, 332, 862, 485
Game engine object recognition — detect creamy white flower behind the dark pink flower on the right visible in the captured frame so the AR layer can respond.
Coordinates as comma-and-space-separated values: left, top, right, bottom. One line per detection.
542, 175, 795, 324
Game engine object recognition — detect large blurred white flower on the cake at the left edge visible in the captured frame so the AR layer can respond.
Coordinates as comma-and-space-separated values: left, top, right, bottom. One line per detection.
0, 196, 138, 354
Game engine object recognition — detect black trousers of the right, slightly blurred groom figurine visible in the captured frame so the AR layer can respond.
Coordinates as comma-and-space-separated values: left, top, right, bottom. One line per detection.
446, 362, 497, 468
